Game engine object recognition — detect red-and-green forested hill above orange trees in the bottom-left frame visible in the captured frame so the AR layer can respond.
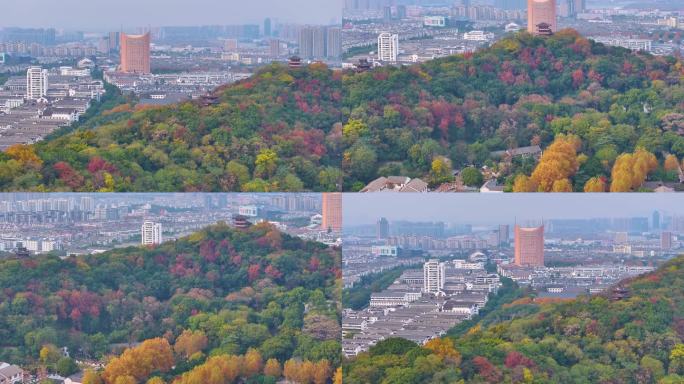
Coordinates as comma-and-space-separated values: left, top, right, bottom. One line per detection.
0, 220, 341, 384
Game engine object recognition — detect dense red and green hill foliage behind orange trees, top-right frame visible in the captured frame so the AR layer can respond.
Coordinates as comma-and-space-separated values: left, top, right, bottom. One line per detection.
343, 30, 684, 190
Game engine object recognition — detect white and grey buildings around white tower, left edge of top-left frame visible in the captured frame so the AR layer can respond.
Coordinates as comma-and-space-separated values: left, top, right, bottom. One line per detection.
0, 59, 105, 150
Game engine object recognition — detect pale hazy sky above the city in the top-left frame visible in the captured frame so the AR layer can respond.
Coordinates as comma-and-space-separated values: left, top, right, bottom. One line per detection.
0, 0, 342, 30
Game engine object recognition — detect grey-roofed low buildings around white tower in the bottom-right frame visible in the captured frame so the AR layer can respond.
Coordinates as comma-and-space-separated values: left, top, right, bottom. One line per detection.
342, 254, 501, 357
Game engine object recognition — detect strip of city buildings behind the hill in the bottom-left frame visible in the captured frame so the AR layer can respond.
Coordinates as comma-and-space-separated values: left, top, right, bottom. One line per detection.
0, 194, 341, 257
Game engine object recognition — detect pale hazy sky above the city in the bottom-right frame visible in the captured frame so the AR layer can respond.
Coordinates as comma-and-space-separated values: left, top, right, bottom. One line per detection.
342, 193, 684, 226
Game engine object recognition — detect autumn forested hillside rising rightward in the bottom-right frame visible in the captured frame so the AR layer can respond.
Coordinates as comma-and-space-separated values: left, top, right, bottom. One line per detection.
343, 256, 684, 384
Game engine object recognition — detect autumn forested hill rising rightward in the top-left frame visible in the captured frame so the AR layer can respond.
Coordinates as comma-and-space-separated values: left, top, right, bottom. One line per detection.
0, 64, 344, 192
